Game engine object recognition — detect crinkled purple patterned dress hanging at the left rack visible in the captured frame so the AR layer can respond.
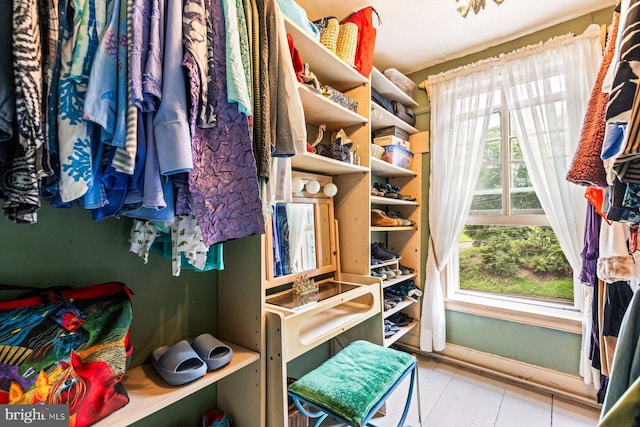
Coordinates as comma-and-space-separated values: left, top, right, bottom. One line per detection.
183, 0, 264, 246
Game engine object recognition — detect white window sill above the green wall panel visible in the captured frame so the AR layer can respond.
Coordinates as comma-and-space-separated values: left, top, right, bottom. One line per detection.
444, 292, 582, 334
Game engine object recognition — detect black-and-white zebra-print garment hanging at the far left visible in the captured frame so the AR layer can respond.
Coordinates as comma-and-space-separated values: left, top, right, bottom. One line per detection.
0, 0, 45, 223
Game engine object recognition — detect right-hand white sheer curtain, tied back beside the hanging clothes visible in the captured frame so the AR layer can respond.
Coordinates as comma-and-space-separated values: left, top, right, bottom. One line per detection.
501, 25, 602, 383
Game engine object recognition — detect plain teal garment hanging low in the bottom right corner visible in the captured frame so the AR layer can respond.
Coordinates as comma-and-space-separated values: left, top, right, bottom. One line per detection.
598, 292, 640, 427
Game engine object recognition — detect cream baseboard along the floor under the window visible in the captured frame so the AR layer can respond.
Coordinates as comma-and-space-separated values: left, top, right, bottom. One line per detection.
399, 343, 601, 409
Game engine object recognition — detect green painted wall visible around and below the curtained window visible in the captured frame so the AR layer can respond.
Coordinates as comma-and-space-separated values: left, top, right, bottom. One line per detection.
409, 7, 613, 375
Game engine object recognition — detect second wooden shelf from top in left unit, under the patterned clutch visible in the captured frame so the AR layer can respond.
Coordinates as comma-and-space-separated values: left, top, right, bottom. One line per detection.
298, 83, 368, 130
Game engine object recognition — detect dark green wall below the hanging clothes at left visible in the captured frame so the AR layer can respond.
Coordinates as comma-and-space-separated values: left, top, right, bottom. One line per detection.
0, 200, 224, 426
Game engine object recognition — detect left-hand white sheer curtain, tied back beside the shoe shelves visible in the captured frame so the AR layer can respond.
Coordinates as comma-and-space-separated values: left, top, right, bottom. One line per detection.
420, 63, 496, 351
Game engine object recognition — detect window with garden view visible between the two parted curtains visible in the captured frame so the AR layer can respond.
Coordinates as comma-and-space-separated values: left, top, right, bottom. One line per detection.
452, 89, 574, 306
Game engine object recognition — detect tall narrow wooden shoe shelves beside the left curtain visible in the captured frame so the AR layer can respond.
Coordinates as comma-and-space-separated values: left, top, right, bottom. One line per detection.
369, 67, 429, 346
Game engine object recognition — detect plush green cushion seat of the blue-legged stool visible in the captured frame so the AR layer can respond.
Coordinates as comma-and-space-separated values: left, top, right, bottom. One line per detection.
289, 341, 416, 427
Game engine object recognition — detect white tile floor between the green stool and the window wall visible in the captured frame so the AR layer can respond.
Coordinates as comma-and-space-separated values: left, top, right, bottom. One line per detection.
322, 358, 599, 427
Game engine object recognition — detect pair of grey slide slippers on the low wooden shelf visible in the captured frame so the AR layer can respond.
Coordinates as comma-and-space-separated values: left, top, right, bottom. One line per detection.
150, 334, 233, 385
